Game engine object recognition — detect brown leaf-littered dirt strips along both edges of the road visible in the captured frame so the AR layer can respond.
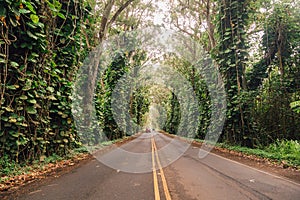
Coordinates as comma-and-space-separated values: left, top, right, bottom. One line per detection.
0, 134, 300, 199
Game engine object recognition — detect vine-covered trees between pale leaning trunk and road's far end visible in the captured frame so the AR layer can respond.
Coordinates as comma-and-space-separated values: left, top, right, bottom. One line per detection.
96, 52, 149, 143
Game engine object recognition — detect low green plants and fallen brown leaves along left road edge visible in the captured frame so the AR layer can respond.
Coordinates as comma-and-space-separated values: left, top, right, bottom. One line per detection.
0, 137, 128, 187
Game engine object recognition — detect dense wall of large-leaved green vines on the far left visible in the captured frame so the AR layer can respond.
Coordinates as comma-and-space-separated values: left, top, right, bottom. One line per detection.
0, 0, 89, 161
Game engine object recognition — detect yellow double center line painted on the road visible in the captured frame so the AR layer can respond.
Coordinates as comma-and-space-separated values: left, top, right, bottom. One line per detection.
151, 137, 171, 200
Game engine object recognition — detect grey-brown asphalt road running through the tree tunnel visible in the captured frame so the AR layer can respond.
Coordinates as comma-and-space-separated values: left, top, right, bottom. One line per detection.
12, 132, 300, 200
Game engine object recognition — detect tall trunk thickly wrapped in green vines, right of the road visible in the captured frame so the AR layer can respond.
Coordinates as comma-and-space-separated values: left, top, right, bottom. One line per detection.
216, 0, 250, 143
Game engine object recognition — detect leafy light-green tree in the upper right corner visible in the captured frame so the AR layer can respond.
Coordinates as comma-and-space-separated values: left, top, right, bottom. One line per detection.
248, 1, 300, 89
